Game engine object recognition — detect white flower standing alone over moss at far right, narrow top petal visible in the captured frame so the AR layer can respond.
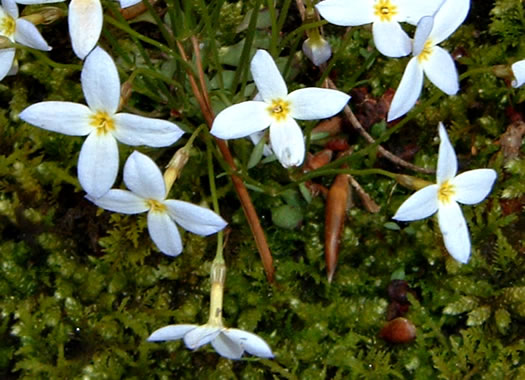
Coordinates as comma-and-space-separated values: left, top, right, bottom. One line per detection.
393, 123, 497, 263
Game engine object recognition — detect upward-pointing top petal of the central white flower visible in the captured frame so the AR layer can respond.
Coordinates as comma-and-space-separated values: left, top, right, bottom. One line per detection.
250, 50, 288, 103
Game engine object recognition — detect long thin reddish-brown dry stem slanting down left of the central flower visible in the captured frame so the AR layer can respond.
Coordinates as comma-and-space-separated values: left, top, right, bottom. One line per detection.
177, 37, 275, 283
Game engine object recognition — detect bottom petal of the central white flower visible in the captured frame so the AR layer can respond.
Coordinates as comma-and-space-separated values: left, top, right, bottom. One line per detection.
270, 118, 305, 168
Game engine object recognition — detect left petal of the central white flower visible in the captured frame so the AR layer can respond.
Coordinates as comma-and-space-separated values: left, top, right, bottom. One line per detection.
210, 100, 273, 140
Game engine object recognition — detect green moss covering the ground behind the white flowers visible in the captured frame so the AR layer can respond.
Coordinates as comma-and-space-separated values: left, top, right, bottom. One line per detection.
0, 0, 525, 380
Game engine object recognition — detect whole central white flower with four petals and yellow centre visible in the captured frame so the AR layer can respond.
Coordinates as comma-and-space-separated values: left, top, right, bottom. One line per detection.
211, 50, 350, 167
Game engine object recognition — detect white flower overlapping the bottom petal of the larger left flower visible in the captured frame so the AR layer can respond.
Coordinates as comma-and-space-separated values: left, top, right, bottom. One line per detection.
87, 151, 227, 256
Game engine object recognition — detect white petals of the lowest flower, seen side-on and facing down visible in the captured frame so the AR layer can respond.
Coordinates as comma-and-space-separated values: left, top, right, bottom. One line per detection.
148, 323, 273, 359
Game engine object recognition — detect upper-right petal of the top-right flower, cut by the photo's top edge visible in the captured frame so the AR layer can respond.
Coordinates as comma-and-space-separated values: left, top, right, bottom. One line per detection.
430, 0, 470, 45
